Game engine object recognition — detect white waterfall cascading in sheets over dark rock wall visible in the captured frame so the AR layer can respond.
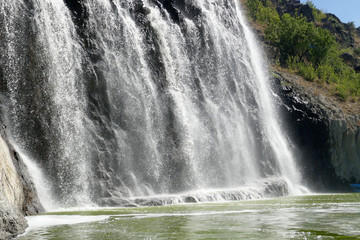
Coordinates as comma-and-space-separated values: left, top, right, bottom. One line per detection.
0, 0, 306, 206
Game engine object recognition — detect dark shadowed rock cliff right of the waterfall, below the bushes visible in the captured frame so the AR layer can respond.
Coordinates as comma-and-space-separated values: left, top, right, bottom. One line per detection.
273, 70, 360, 191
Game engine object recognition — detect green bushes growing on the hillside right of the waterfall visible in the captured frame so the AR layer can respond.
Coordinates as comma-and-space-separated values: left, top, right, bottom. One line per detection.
247, 0, 360, 101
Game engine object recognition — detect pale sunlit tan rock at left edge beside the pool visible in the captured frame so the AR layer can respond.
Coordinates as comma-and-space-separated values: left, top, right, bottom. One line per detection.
0, 129, 43, 239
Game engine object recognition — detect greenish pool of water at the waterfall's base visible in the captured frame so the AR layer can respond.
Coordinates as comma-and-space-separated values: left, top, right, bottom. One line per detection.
18, 194, 360, 240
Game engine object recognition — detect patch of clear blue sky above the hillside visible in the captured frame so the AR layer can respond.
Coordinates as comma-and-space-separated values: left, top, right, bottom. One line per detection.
301, 0, 360, 27
